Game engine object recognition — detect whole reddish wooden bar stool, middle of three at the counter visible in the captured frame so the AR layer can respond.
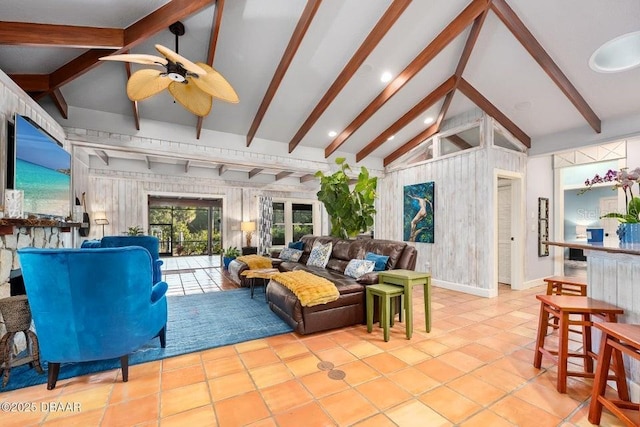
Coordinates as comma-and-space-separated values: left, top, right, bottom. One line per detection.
533, 295, 624, 393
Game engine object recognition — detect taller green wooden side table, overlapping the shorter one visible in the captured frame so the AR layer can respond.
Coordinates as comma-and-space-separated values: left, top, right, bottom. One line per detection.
378, 270, 431, 339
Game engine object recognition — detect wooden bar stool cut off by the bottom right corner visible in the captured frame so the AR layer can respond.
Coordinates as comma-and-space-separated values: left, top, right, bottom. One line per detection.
589, 322, 640, 426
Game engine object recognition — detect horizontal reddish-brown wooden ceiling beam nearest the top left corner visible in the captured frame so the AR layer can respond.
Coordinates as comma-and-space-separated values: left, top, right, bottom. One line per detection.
0, 21, 124, 49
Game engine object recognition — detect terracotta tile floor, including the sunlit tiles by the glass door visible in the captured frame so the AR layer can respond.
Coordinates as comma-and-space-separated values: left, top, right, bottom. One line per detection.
0, 257, 620, 427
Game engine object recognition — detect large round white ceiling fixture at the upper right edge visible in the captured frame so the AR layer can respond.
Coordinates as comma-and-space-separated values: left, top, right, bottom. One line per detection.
589, 31, 640, 73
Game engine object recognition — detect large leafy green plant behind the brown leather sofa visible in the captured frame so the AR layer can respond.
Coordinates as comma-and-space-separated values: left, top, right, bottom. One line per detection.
315, 157, 378, 239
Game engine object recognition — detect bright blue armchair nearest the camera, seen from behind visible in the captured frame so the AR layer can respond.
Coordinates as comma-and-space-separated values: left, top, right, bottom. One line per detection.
18, 246, 167, 390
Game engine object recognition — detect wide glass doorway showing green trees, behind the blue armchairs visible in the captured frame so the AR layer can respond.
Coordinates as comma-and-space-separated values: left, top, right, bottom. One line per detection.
148, 196, 222, 256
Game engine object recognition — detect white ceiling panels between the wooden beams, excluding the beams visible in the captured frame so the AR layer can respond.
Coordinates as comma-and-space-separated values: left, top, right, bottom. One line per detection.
0, 0, 640, 176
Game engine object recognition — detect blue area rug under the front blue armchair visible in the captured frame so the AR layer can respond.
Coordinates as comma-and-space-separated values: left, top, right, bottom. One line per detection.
0, 288, 292, 392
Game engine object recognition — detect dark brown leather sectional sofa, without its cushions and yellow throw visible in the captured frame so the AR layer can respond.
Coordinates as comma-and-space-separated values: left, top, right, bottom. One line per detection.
267, 235, 417, 334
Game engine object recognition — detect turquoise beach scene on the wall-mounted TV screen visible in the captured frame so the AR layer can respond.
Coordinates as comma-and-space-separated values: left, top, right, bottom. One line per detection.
15, 117, 71, 218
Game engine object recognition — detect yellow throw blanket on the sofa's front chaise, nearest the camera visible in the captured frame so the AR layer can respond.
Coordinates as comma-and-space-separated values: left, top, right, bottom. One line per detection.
271, 271, 340, 307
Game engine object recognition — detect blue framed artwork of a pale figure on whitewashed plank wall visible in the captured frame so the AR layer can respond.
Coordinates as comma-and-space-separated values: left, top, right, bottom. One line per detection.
402, 181, 435, 243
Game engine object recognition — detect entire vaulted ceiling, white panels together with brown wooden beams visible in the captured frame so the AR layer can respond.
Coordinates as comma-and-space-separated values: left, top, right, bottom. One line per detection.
0, 0, 640, 178
